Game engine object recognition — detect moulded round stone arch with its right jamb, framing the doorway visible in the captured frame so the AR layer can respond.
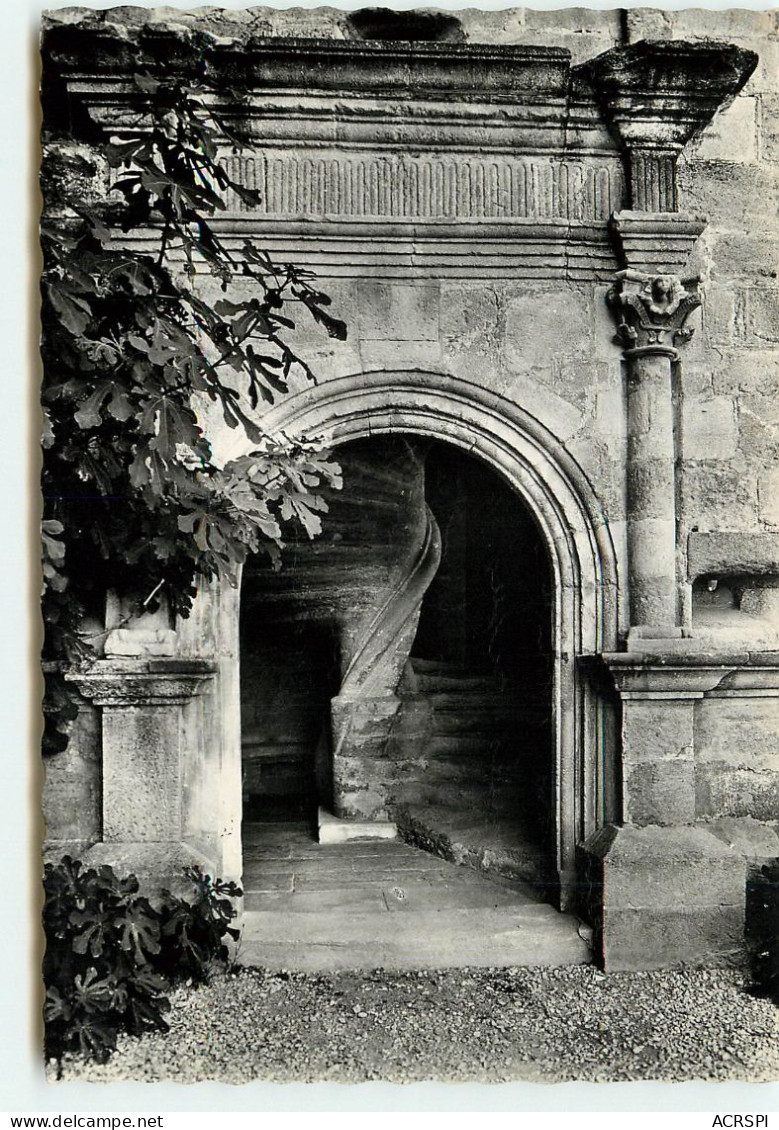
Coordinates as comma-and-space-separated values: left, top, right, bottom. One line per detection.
215, 370, 617, 903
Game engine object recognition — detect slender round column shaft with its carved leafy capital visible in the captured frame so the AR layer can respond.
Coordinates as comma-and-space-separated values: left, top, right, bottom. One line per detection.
608, 270, 701, 636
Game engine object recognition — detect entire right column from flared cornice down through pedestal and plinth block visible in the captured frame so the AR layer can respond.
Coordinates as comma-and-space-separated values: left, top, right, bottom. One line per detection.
581, 41, 758, 970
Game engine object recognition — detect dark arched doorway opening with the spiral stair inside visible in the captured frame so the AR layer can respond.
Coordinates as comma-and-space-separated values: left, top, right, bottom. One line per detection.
240, 434, 556, 888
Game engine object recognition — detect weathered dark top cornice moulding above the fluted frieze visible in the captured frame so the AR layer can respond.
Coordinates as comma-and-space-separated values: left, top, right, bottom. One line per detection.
46, 26, 615, 170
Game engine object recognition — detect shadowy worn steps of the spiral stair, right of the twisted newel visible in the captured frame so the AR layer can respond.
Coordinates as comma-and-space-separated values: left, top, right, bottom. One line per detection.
386, 658, 556, 890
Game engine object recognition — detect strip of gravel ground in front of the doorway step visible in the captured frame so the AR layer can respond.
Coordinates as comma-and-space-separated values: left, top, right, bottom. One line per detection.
54, 966, 779, 1083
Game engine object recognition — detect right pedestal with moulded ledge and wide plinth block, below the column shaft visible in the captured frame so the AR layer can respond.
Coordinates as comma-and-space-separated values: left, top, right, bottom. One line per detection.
582, 655, 779, 970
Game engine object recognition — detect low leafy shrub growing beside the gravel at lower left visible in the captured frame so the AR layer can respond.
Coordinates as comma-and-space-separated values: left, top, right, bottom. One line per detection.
43, 855, 241, 1062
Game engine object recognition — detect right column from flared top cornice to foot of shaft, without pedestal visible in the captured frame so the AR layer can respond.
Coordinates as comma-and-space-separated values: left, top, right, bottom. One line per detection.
583, 40, 758, 638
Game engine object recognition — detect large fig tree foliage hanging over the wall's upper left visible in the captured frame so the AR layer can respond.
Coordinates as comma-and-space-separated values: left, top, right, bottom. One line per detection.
41, 61, 346, 748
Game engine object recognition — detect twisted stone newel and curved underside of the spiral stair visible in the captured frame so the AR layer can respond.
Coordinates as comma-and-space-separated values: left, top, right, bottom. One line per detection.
242, 440, 441, 820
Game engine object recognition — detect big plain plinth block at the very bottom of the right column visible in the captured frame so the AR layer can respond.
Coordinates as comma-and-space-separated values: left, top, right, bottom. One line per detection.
583, 825, 746, 972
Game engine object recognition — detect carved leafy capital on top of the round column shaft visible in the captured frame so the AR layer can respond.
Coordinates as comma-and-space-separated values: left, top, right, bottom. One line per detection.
606, 270, 701, 360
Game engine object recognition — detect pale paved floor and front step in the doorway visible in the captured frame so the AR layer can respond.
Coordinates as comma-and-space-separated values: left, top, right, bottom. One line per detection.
239, 823, 592, 972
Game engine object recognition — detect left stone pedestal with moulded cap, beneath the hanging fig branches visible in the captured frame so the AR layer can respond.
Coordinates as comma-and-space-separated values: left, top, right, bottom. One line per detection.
70, 658, 213, 886
